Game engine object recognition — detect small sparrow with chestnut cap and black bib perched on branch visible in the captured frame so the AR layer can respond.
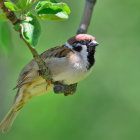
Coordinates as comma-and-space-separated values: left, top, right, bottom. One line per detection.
0, 34, 98, 132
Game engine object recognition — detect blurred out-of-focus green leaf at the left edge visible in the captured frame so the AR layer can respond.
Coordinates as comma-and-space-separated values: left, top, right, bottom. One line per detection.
0, 22, 12, 54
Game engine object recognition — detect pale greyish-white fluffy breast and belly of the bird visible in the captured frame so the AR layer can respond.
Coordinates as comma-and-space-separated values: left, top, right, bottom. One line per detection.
48, 53, 89, 84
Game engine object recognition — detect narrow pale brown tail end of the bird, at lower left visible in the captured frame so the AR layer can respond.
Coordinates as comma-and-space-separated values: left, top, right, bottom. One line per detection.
0, 105, 19, 133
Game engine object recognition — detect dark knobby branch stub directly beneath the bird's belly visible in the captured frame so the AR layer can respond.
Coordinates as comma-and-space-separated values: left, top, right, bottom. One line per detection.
53, 82, 77, 96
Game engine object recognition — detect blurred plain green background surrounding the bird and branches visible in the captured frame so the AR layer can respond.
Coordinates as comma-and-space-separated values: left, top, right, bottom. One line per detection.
0, 0, 140, 140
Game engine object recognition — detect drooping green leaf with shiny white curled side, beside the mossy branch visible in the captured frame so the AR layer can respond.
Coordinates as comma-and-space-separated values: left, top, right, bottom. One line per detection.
20, 13, 41, 46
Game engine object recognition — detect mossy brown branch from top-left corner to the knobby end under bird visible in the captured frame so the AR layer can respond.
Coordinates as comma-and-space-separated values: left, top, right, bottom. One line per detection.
0, 0, 77, 96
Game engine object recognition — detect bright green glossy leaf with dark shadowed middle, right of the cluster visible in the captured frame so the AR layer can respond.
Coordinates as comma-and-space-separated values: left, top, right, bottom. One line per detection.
35, 1, 70, 20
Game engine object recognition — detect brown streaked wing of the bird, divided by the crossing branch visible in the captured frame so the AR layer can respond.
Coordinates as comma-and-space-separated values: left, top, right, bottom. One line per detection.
14, 46, 72, 89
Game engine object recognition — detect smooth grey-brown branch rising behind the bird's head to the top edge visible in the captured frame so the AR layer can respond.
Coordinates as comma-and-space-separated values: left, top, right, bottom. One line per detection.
77, 0, 96, 34
